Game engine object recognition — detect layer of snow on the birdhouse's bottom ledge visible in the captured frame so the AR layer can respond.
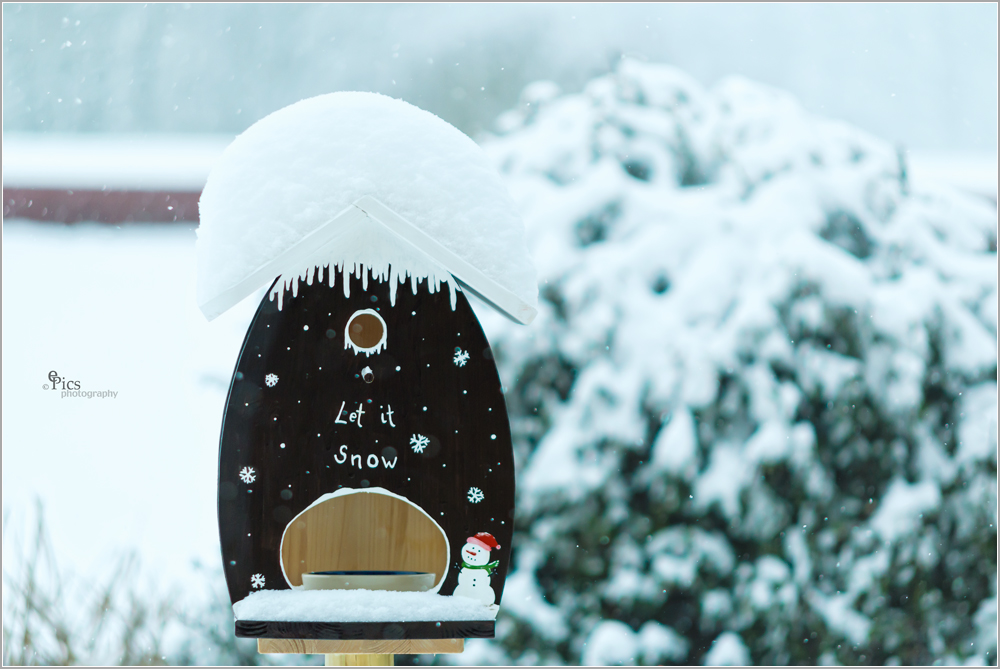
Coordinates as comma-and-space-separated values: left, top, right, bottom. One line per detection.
233, 590, 497, 623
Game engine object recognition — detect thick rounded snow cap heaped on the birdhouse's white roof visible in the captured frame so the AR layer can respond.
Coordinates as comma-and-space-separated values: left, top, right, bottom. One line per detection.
197, 92, 538, 319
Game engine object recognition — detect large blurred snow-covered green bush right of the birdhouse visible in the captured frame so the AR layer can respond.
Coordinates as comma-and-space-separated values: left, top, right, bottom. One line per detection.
470, 61, 997, 664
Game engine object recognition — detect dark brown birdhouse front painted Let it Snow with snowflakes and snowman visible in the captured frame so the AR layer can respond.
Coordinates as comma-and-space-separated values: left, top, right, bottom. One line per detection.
219, 264, 514, 639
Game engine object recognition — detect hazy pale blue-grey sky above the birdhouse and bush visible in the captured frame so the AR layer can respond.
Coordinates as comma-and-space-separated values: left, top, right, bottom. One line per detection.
3, 3, 997, 153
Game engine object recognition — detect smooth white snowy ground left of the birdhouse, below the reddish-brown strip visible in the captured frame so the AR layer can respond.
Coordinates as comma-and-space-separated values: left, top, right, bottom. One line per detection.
3, 221, 259, 585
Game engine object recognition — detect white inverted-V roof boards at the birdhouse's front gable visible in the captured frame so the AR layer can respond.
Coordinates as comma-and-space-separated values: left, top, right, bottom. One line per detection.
198, 195, 538, 325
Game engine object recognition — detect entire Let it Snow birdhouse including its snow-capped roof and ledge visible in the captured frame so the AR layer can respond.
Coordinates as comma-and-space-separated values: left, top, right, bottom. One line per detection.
199, 94, 536, 664
